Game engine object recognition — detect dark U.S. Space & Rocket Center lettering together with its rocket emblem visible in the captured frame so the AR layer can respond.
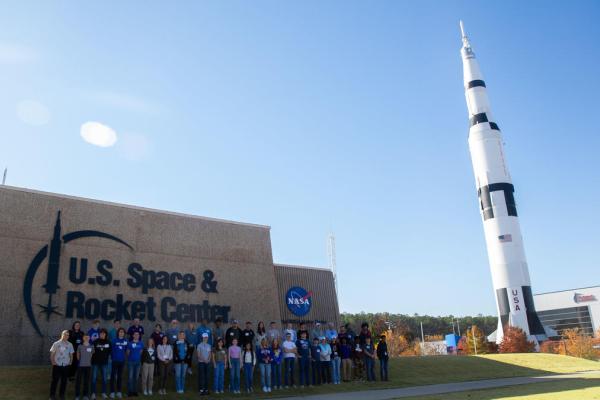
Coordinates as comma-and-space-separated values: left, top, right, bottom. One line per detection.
23, 211, 231, 336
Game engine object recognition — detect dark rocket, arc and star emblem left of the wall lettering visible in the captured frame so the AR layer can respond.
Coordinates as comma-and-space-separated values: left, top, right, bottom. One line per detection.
23, 211, 133, 336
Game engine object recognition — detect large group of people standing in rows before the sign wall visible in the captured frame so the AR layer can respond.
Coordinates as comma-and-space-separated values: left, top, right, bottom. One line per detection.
50, 319, 389, 400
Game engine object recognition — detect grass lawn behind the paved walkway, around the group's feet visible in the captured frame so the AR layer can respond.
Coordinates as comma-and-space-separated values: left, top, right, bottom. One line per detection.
0, 354, 600, 400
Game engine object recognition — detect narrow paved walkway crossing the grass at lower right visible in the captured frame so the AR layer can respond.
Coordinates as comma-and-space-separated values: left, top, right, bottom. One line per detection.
276, 371, 600, 400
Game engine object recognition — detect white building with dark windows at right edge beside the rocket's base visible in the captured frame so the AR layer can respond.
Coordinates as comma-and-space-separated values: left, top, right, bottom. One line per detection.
533, 286, 600, 335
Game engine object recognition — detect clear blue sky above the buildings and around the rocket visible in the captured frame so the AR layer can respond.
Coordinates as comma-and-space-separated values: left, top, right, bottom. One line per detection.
0, 1, 600, 315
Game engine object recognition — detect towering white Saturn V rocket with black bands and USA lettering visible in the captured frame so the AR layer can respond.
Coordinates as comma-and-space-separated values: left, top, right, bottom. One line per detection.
460, 21, 545, 343
